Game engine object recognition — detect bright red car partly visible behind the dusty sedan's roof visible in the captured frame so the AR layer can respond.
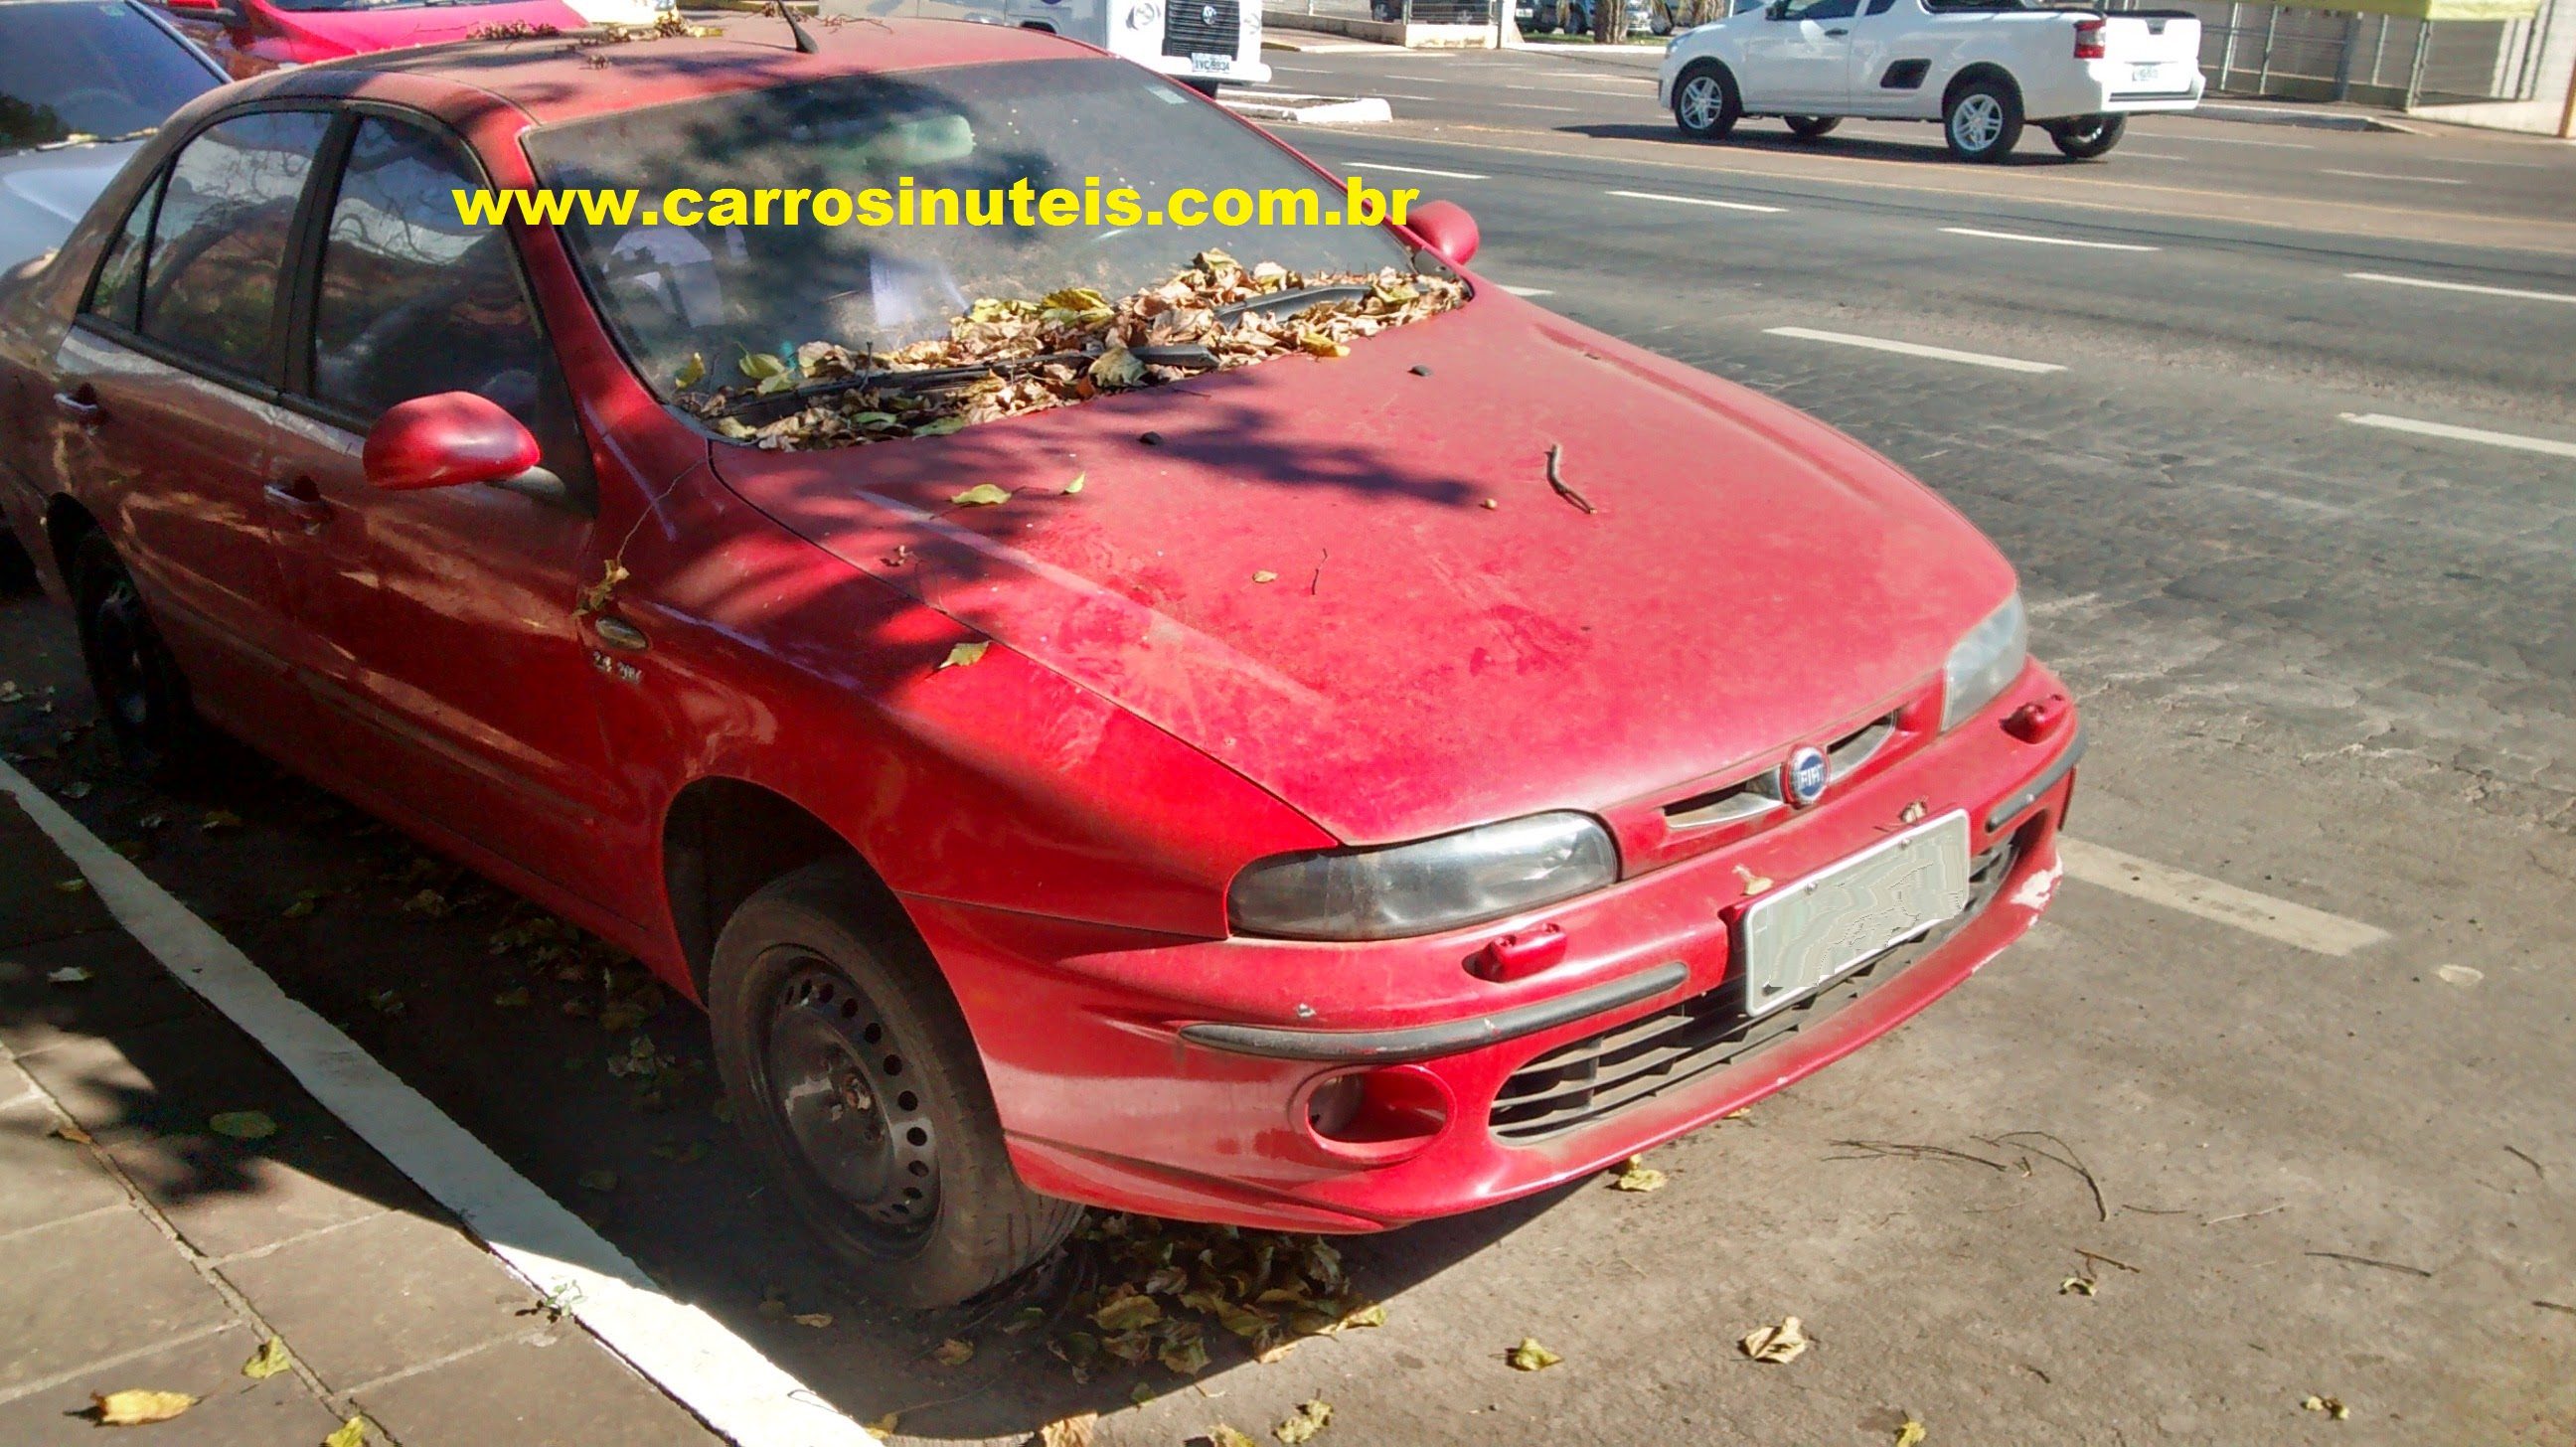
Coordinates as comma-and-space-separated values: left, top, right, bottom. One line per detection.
157, 0, 589, 80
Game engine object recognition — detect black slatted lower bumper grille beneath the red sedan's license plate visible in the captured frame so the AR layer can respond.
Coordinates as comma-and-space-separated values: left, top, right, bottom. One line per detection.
1487, 842, 2014, 1146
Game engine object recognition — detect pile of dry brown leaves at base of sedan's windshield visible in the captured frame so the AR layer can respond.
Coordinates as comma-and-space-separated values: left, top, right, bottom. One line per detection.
673, 249, 1466, 450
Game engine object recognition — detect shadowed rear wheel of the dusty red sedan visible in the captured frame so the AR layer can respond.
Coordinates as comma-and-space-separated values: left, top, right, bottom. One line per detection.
67, 528, 206, 783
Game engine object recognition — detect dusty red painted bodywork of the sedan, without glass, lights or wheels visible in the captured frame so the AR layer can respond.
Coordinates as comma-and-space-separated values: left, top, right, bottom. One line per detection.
0, 21, 2074, 1230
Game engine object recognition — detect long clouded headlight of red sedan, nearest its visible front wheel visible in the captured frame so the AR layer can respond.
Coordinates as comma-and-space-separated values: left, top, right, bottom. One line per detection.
1226, 814, 1618, 940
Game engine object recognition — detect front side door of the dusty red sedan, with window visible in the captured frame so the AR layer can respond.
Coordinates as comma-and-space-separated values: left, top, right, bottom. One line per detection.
268, 110, 636, 898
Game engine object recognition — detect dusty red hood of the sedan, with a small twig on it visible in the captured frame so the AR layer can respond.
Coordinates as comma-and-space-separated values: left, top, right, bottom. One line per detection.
717, 288, 2012, 845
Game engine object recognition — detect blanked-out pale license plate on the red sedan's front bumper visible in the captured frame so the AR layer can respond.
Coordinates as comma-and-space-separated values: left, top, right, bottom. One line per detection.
1739, 814, 1968, 1015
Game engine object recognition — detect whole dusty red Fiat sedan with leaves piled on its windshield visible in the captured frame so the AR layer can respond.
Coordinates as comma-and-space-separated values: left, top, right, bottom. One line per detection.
0, 18, 2081, 1303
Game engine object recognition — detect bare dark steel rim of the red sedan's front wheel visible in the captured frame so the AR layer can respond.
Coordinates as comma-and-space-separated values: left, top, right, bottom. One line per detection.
757, 950, 940, 1246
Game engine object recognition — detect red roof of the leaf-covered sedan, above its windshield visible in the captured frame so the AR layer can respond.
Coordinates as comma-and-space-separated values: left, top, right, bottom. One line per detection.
248, 18, 1102, 126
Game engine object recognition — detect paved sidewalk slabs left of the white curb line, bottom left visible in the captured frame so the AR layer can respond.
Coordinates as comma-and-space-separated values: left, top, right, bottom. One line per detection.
0, 793, 719, 1447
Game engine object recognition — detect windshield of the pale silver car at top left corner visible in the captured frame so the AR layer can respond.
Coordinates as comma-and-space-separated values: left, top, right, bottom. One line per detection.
0, 0, 222, 149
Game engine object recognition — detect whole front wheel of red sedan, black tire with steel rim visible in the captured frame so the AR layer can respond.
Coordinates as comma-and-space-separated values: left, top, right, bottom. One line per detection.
706, 860, 1082, 1308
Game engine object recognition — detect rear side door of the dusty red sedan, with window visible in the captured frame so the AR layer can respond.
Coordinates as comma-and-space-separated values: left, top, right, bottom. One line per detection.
54, 110, 330, 754
